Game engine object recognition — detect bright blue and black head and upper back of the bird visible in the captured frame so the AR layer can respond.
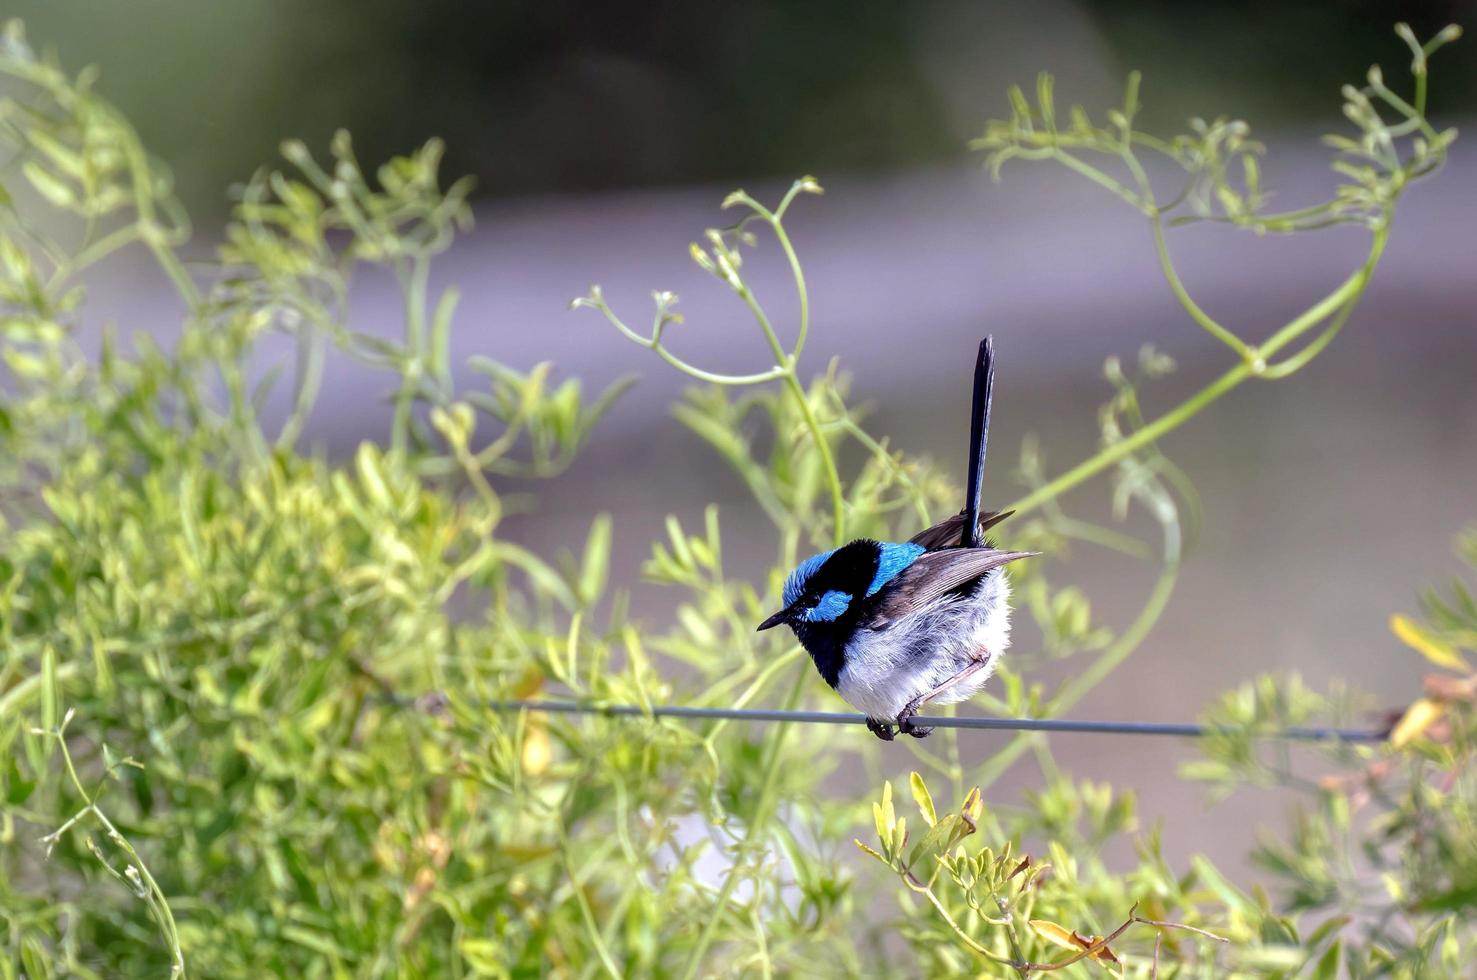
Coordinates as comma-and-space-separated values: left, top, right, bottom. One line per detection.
759, 539, 923, 639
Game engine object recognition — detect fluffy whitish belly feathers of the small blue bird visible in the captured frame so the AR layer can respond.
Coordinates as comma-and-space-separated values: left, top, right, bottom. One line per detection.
836, 568, 1010, 720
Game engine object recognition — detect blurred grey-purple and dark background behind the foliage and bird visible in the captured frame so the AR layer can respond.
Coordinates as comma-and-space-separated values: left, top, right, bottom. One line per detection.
9, 0, 1477, 866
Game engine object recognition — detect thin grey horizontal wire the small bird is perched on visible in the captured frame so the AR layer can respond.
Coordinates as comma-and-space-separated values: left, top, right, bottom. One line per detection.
425, 700, 1385, 742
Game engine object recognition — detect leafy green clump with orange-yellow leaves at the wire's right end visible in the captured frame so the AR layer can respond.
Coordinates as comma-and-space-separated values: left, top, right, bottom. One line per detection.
1183, 531, 1477, 977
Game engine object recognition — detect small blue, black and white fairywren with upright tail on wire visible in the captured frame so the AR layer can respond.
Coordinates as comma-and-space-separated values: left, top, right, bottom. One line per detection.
759, 337, 1035, 741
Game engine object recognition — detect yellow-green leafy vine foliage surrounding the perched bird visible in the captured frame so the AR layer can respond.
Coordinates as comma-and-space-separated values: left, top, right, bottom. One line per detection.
0, 15, 1477, 977
